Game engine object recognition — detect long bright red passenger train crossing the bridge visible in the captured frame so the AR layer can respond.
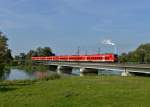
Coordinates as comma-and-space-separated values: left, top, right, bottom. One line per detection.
31, 54, 118, 62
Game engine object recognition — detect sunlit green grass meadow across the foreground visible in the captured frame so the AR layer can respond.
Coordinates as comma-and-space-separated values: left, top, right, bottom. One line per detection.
0, 76, 150, 107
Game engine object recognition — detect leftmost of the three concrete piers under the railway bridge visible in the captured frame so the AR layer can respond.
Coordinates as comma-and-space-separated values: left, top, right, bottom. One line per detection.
57, 66, 73, 74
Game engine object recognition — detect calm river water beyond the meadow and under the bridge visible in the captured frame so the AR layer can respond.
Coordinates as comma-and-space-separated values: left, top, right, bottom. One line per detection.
0, 68, 121, 80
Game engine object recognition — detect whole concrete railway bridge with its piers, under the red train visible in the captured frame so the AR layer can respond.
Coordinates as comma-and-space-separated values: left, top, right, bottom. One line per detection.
42, 61, 150, 76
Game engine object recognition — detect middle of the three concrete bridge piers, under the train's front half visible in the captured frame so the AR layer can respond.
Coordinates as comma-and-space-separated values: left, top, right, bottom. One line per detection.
80, 68, 98, 76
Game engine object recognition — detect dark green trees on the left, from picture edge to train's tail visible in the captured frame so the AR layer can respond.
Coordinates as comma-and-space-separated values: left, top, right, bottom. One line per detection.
0, 32, 55, 71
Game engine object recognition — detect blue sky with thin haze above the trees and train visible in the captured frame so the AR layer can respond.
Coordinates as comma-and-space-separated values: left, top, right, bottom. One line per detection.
0, 0, 150, 55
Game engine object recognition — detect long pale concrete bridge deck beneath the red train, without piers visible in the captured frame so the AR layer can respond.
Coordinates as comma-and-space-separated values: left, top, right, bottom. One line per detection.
38, 61, 150, 74
